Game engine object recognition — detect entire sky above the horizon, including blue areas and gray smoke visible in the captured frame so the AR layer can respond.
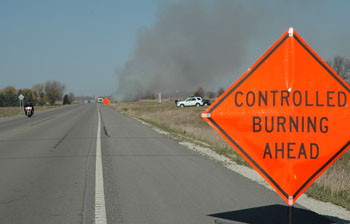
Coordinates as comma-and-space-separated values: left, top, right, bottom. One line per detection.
0, 0, 350, 96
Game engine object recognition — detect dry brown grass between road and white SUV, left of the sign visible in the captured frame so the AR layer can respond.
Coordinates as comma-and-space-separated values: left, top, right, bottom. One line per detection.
111, 100, 245, 163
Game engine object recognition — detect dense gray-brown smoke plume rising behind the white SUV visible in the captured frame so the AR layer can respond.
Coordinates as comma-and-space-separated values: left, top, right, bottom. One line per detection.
114, 0, 268, 100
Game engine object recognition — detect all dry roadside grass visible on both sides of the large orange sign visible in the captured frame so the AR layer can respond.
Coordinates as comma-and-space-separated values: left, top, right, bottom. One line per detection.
111, 100, 350, 210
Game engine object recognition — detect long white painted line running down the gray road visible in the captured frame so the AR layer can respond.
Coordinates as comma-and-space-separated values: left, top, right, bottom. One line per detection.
95, 105, 107, 224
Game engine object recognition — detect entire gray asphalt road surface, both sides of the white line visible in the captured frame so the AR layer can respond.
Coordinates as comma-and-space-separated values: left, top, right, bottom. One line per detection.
0, 104, 338, 224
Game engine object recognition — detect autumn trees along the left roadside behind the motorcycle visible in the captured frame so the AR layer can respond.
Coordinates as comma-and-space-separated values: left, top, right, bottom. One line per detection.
0, 81, 75, 107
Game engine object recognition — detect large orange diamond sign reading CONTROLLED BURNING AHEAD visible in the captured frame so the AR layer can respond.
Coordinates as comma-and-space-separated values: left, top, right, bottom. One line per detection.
202, 28, 350, 205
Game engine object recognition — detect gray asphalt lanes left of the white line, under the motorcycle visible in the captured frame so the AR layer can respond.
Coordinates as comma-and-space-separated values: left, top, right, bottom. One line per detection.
0, 105, 97, 223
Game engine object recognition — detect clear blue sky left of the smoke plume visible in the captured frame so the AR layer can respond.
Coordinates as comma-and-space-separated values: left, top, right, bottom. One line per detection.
0, 0, 156, 95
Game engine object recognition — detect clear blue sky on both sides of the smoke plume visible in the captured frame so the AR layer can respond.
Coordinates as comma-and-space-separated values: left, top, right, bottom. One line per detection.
0, 0, 350, 96
